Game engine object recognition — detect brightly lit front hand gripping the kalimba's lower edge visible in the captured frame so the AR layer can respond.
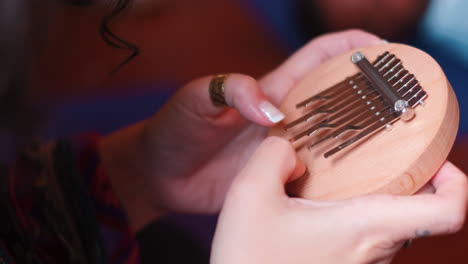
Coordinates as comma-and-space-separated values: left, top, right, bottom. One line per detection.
211, 138, 468, 264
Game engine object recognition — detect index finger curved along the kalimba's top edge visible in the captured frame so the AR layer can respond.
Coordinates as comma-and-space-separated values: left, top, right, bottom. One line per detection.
261, 30, 383, 104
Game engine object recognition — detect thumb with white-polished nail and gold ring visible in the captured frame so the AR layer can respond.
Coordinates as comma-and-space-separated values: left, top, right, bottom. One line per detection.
180, 74, 284, 126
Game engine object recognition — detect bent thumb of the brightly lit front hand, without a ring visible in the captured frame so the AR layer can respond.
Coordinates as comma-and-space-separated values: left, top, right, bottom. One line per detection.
233, 137, 306, 198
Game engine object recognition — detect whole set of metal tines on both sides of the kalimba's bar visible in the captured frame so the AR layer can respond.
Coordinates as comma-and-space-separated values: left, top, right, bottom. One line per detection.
285, 52, 427, 158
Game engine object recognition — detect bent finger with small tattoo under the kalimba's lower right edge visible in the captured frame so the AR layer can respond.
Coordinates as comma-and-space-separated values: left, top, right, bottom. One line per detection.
362, 162, 468, 241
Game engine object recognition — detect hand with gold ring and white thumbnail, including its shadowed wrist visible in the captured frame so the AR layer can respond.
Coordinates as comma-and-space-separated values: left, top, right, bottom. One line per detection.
101, 30, 381, 230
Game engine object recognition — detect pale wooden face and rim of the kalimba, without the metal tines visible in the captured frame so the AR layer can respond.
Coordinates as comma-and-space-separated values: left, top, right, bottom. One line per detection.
270, 44, 458, 200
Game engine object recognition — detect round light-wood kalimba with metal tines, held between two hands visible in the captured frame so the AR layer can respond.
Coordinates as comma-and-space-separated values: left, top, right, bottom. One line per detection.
270, 43, 458, 200
